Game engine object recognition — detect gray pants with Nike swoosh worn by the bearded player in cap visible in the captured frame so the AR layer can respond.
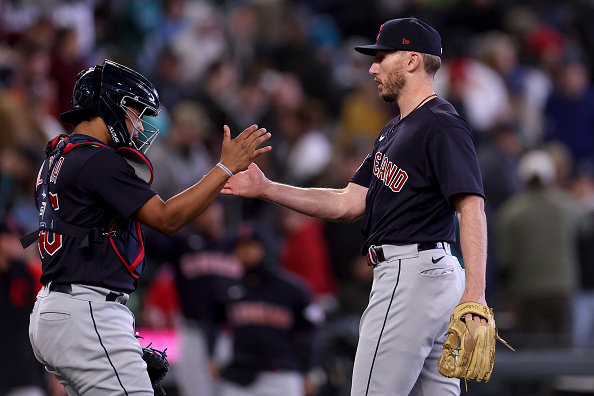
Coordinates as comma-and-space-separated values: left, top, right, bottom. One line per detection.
351, 245, 465, 396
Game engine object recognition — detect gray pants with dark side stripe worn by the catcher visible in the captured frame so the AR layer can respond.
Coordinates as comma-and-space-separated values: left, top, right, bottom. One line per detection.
29, 285, 154, 396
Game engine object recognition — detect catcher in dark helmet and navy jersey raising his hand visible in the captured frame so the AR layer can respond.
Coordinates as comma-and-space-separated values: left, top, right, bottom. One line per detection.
29, 60, 270, 395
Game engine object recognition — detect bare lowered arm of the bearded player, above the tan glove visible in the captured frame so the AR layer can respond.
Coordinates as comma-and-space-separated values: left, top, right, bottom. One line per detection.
456, 195, 487, 305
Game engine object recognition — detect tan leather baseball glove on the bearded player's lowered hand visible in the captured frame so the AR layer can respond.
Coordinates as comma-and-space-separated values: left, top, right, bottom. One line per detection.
437, 302, 514, 382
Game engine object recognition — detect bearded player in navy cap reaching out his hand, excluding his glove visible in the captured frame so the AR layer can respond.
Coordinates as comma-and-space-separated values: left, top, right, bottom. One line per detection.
222, 18, 487, 396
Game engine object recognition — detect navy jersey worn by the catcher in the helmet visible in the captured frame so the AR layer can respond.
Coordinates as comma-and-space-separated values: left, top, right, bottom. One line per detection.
36, 135, 156, 292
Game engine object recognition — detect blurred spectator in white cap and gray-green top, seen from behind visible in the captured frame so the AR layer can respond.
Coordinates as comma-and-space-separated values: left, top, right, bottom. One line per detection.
496, 150, 582, 347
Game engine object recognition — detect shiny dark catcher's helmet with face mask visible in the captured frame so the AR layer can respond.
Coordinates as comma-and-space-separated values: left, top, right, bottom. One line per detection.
60, 59, 160, 153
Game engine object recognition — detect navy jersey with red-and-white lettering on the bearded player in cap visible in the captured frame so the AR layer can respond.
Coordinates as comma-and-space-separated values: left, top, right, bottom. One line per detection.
350, 98, 484, 253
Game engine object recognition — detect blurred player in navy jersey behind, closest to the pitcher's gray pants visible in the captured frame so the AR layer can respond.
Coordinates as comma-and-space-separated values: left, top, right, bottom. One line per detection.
214, 221, 324, 396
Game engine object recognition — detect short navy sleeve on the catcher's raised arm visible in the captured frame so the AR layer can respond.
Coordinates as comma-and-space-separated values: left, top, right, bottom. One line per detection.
78, 150, 157, 218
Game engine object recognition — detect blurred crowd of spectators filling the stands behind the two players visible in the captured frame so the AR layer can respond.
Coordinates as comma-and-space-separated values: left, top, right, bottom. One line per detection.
0, 0, 594, 395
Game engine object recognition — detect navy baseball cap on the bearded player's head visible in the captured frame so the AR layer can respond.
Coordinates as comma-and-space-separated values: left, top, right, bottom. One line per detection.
355, 17, 441, 58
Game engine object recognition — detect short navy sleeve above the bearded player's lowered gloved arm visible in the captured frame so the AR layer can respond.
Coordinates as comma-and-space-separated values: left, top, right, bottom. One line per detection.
428, 127, 485, 210
